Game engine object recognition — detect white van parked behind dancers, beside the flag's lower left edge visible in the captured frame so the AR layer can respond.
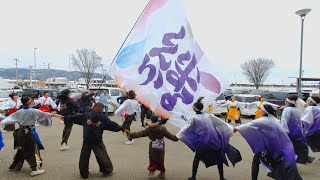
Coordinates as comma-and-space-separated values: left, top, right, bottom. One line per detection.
89, 87, 123, 113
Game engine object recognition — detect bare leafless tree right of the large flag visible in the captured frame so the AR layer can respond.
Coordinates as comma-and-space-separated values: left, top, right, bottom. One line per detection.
241, 58, 275, 89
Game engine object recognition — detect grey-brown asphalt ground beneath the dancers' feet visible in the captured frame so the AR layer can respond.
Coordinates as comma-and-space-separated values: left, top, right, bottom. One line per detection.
0, 116, 320, 180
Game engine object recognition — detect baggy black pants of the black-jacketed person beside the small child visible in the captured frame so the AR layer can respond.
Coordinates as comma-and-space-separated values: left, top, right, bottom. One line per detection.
79, 143, 113, 178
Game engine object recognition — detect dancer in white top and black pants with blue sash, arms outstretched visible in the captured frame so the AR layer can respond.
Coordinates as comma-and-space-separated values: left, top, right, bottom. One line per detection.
0, 96, 61, 176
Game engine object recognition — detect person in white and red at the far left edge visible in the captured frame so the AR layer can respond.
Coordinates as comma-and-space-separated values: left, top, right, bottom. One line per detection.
0, 92, 22, 132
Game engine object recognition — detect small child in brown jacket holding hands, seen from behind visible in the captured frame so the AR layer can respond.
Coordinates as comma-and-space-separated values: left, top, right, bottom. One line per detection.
127, 116, 178, 179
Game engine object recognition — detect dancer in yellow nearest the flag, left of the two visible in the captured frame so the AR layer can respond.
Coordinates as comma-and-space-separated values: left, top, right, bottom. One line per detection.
218, 96, 246, 124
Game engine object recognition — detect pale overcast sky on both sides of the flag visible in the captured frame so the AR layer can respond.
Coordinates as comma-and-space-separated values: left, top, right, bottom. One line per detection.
0, 0, 320, 83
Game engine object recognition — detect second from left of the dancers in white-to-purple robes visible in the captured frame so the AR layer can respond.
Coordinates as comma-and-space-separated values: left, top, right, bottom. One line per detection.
233, 104, 302, 180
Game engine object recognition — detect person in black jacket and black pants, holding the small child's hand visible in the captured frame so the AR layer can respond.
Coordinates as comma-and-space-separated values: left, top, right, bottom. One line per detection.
64, 103, 125, 178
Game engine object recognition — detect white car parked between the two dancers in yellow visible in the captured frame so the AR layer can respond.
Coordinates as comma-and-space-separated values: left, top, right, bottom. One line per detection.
234, 94, 260, 116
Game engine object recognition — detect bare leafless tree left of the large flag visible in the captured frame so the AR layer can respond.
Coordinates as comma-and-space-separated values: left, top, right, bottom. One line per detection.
71, 49, 102, 89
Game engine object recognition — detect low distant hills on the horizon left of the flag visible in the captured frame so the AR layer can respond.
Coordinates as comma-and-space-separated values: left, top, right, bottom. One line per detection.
0, 68, 112, 81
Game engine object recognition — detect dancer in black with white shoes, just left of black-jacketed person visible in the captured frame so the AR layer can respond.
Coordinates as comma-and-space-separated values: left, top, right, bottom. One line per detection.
57, 89, 79, 151
